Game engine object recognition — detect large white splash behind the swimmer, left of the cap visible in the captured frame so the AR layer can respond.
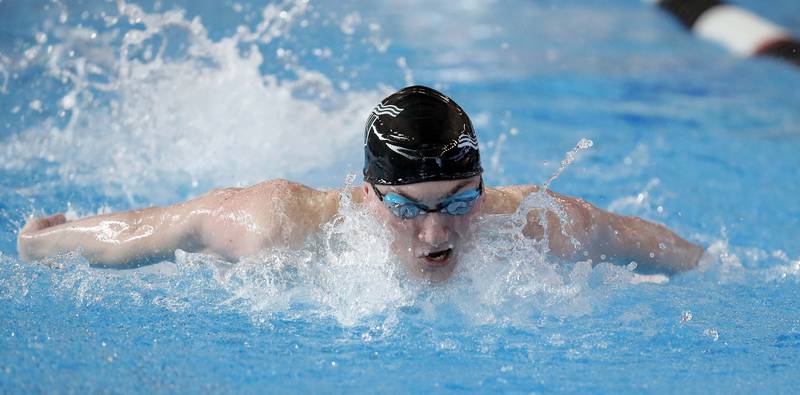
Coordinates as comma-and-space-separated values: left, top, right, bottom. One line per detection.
0, 1, 382, 204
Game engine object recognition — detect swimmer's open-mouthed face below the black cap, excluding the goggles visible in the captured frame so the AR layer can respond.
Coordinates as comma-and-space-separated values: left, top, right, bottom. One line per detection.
364, 176, 484, 281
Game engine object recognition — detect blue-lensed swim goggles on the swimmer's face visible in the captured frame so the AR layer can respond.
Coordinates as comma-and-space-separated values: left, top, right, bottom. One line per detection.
372, 179, 483, 219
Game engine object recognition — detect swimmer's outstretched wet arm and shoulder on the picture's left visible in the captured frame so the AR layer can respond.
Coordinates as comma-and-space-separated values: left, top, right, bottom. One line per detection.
17, 180, 339, 265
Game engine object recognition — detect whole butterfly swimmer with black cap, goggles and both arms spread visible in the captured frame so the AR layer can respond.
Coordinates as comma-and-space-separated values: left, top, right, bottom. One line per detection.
17, 86, 703, 281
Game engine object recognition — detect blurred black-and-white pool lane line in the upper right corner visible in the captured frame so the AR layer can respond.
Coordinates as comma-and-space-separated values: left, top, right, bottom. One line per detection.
651, 0, 800, 67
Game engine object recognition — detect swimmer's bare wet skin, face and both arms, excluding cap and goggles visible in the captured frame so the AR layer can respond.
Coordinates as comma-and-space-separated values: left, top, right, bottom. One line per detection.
17, 176, 703, 280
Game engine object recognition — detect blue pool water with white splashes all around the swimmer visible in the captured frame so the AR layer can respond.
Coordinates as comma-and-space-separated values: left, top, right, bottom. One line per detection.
0, 0, 800, 393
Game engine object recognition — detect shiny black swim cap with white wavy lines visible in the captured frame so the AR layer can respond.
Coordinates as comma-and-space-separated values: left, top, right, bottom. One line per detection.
364, 86, 483, 185
